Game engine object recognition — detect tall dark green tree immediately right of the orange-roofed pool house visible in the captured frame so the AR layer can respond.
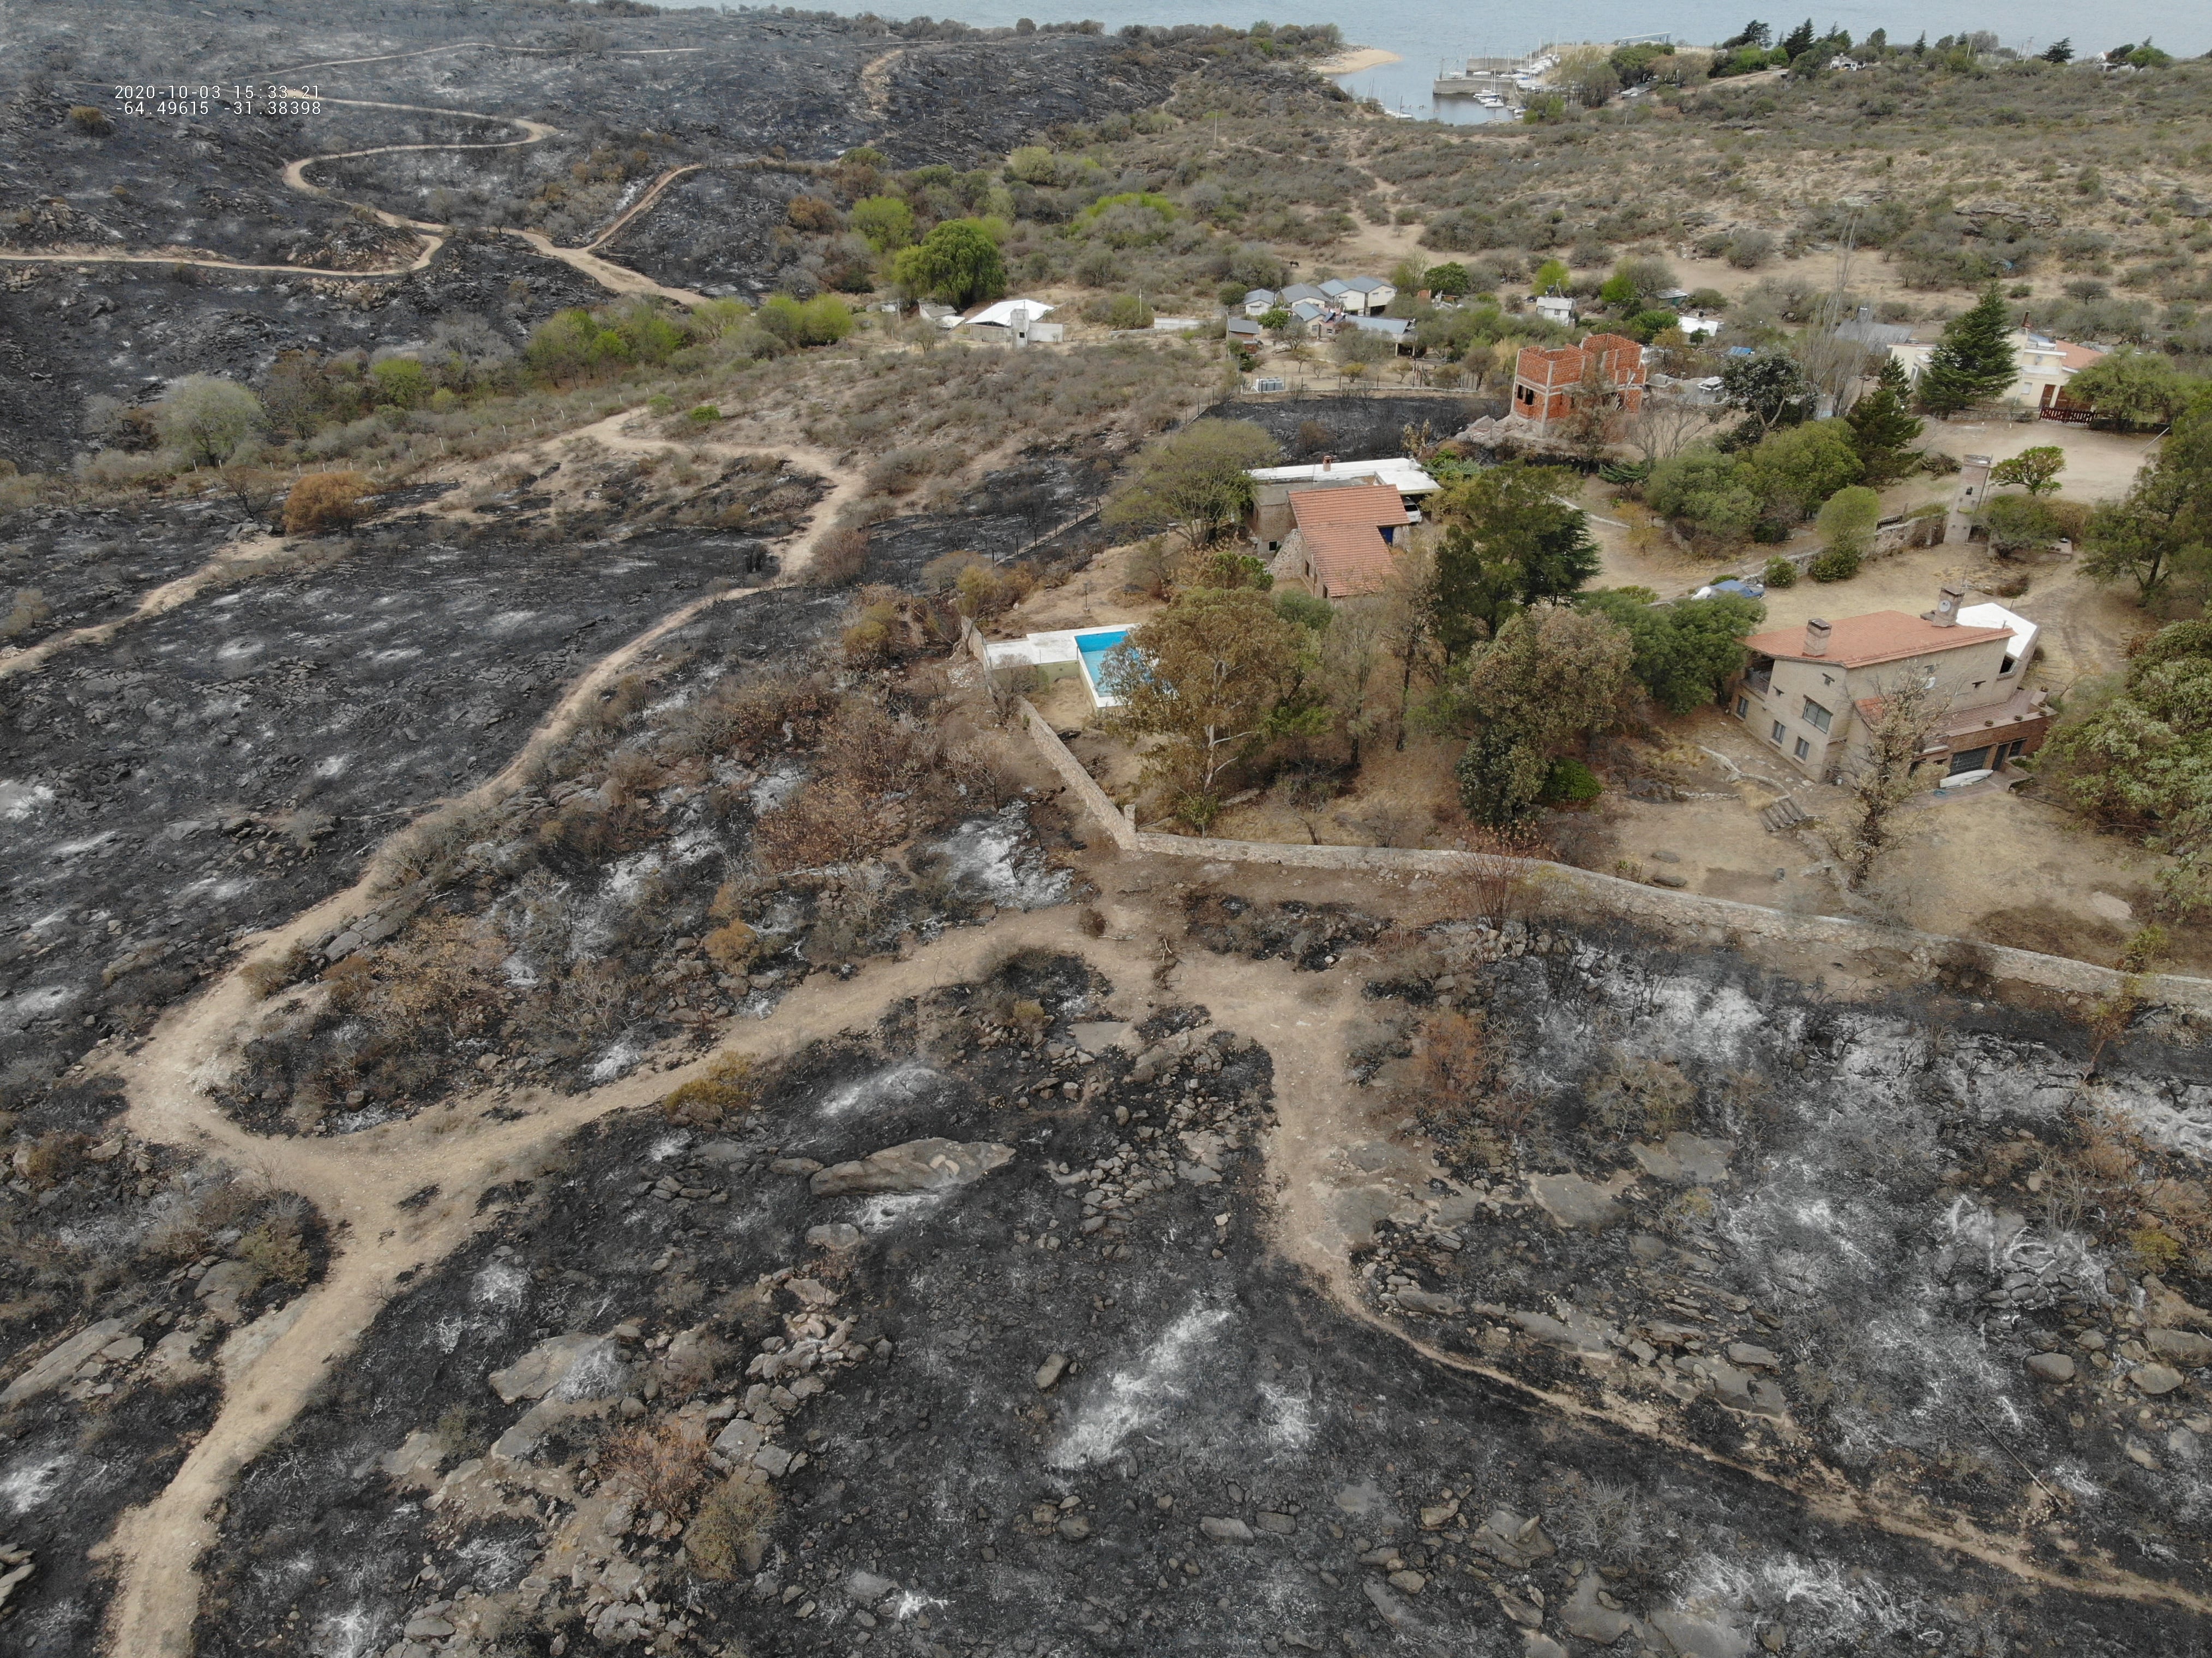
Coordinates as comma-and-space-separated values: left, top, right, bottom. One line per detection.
1431, 460, 1599, 657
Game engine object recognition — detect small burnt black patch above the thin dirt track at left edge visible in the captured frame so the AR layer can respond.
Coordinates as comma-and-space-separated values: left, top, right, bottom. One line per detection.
0, 497, 241, 648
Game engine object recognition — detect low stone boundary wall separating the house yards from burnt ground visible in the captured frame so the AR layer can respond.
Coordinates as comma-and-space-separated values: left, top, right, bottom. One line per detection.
1022, 701, 2212, 1012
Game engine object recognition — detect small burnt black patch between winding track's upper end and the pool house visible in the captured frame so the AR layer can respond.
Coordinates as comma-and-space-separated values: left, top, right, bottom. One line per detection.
867, 455, 1113, 586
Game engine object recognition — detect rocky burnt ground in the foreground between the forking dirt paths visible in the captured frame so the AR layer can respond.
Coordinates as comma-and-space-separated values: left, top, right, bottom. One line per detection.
197, 959, 2195, 1658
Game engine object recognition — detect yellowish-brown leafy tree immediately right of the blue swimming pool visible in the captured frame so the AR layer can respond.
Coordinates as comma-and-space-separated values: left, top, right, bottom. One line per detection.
1106, 588, 1312, 829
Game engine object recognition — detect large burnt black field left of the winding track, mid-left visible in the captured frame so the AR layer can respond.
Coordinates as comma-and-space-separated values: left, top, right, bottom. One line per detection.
0, 520, 819, 1109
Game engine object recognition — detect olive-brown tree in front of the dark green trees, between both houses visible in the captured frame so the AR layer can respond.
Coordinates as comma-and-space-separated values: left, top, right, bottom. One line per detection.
1447, 604, 1634, 825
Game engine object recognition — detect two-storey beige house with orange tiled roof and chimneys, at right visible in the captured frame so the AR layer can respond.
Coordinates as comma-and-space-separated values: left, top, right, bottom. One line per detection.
1728, 588, 2051, 783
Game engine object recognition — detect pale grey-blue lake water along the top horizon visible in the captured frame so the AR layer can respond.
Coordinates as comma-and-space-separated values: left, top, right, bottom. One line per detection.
747, 0, 2212, 122
